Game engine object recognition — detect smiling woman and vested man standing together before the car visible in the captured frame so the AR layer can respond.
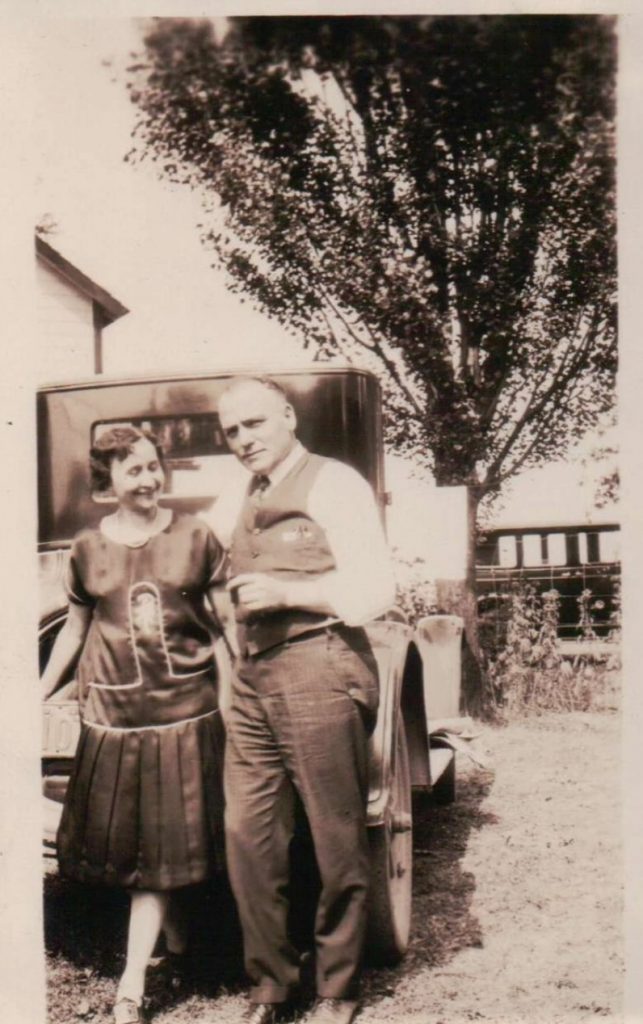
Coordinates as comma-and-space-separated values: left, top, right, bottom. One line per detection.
43, 378, 394, 1024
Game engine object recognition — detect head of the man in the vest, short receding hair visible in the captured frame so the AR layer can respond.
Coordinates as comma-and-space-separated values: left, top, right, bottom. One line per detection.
219, 381, 297, 475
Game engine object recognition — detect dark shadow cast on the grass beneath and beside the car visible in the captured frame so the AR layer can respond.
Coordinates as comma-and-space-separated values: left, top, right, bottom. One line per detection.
45, 769, 496, 1019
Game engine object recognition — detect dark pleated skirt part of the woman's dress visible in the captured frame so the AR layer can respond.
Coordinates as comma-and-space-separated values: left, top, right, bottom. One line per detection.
57, 712, 224, 890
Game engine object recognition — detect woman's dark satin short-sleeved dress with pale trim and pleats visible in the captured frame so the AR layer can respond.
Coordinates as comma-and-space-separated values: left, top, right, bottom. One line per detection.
57, 515, 225, 890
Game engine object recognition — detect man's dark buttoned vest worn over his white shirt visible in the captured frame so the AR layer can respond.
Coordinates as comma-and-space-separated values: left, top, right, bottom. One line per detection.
229, 452, 336, 654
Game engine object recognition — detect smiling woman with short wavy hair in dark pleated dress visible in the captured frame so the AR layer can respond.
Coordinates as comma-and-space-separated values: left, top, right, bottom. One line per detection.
42, 427, 224, 1024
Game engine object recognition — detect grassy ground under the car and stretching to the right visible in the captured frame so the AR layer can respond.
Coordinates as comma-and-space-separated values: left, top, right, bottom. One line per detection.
45, 711, 624, 1024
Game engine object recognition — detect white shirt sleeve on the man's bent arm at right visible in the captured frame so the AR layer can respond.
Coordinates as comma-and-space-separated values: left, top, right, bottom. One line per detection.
308, 461, 395, 626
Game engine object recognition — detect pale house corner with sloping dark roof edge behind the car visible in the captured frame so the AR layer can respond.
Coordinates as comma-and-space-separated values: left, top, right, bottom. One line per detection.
36, 234, 129, 383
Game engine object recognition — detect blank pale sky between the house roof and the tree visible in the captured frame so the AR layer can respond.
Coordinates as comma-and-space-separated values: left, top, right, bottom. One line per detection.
35, 18, 306, 375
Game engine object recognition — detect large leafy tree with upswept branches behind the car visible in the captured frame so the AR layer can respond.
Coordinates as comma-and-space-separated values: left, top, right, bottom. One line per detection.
130, 15, 616, 708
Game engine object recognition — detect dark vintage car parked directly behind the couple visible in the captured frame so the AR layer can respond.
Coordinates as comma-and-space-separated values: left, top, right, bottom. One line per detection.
37, 366, 462, 963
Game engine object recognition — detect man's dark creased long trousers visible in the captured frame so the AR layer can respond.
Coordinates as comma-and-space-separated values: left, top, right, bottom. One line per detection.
224, 627, 379, 1002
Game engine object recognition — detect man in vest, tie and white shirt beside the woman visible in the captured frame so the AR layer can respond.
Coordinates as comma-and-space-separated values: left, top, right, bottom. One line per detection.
219, 378, 394, 1024
